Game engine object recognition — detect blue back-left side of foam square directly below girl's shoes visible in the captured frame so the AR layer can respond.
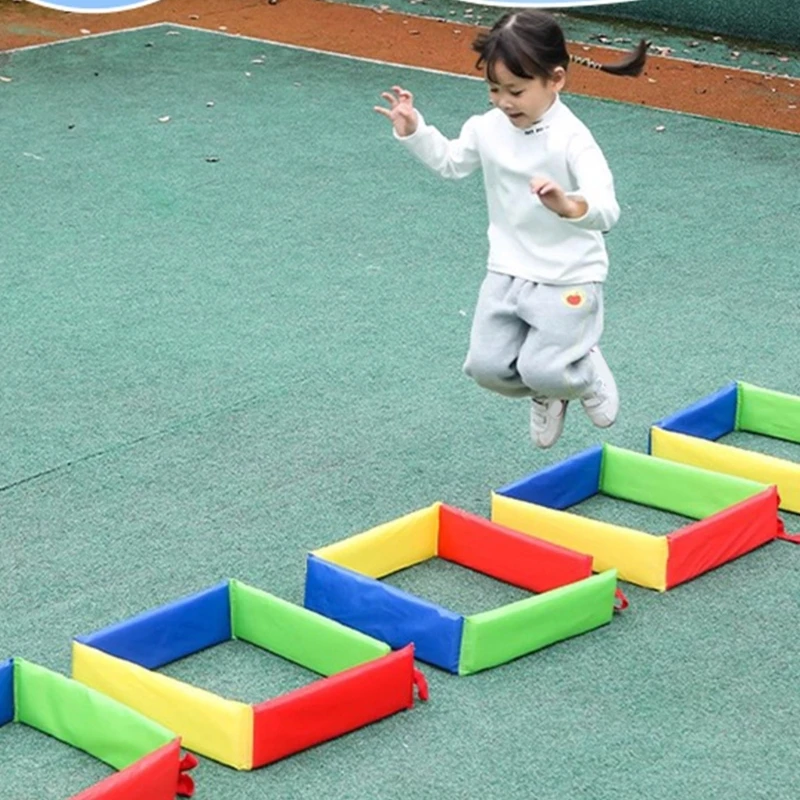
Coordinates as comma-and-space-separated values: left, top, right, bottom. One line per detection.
496, 445, 603, 509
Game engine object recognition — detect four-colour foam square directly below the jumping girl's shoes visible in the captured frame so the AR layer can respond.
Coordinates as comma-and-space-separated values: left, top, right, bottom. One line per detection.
492, 445, 782, 591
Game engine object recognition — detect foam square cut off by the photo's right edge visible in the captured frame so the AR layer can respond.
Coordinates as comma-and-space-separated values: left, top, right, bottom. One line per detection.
650, 381, 800, 513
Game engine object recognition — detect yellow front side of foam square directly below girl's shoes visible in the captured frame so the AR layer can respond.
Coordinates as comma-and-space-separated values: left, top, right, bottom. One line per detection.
492, 493, 669, 592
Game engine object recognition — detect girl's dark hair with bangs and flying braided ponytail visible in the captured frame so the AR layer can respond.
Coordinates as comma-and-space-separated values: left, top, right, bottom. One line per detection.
472, 11, 650, 83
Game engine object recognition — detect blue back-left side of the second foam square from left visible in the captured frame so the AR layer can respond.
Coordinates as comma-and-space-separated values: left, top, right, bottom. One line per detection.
76, 581, 232, 669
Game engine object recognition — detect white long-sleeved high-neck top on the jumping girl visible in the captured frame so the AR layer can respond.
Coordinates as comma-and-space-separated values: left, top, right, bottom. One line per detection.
395, 98, 619, 285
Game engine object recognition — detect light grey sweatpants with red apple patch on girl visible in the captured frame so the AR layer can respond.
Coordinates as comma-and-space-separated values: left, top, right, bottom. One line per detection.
464, 272, 603, 400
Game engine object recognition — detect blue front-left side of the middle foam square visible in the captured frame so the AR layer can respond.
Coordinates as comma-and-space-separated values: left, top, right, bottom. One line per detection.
305, 555, 464, 673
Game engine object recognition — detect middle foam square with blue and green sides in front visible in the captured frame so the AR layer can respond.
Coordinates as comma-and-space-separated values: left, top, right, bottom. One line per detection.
305, 503, 617, 675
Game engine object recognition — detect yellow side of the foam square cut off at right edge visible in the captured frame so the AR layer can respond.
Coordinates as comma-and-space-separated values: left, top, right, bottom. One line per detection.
650, 428, 800, 512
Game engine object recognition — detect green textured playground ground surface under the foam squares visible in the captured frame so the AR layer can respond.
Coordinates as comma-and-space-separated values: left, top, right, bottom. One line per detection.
0, 27, 800, 800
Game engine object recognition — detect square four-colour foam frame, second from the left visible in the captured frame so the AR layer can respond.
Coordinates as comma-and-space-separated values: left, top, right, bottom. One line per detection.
72, 580, 427, 770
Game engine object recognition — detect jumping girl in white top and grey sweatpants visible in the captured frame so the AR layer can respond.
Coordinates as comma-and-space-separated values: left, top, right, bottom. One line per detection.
375, 11, 648, 447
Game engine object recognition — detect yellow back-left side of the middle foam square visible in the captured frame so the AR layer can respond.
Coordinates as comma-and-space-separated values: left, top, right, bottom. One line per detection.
314, 503, 441, 578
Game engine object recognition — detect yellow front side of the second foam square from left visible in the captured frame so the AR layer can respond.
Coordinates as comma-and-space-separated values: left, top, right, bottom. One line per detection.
72, 642, 253, 770
